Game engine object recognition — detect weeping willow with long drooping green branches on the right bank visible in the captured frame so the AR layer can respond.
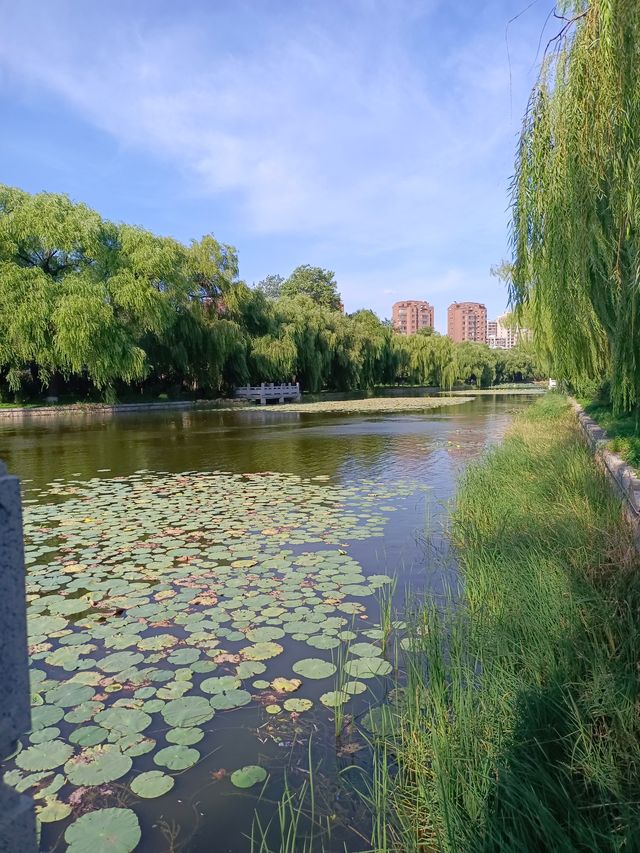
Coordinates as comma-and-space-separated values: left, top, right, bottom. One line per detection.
511, 0, 640, 411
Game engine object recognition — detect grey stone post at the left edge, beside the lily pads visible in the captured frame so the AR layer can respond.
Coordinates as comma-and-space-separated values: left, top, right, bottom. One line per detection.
0, 462, 37, 853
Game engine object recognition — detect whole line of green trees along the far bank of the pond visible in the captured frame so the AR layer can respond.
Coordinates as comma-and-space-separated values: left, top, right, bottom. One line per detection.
0, 186, 537, 399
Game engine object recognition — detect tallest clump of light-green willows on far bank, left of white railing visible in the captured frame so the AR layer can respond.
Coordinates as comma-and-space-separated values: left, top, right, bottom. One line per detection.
0, 187, 239, 392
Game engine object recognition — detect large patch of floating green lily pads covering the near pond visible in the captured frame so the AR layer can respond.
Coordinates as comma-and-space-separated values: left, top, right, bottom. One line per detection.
4, 472, 412, 851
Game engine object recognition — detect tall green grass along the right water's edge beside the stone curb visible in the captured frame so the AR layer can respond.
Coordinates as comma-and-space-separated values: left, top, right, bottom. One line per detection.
371, 395, 640, 853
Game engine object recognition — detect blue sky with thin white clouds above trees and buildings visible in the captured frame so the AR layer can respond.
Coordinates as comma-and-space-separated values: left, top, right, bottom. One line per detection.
0, 0, 552, 330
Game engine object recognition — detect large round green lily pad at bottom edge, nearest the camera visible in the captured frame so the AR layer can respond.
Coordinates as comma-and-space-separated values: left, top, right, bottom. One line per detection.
64, 809, 142, 853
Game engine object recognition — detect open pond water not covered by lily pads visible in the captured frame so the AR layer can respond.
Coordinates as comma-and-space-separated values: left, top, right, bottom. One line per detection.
0, 395, 531, 853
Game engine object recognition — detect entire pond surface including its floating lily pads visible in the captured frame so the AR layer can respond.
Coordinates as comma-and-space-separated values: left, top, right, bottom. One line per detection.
0, 395, 531, 853
